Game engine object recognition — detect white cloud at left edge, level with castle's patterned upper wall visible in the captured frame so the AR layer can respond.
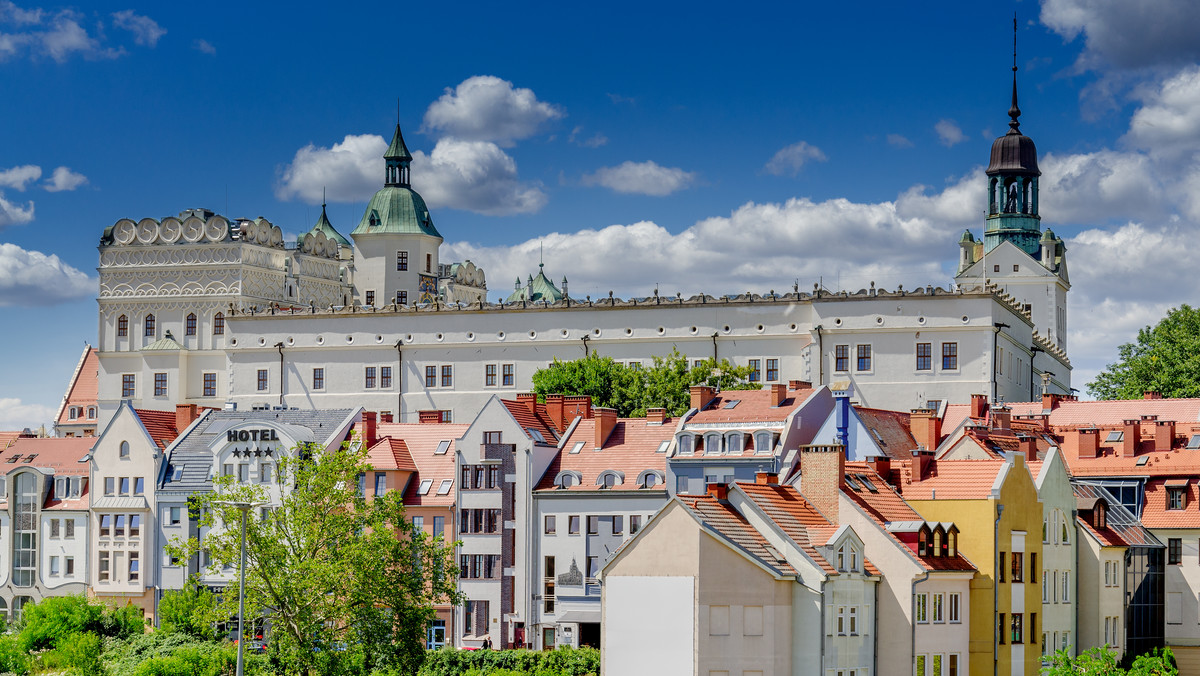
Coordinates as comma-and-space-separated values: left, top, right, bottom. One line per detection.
0, 244, 100, 307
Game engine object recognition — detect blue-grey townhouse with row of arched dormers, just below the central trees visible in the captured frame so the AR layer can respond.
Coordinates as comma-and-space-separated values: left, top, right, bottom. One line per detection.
667, 381, 833, 495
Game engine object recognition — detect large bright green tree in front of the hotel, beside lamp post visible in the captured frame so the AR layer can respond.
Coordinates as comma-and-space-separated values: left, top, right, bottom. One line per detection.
172, 442, 458, 674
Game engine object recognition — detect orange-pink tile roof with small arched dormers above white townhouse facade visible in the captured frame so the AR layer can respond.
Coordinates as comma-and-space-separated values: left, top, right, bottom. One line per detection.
536, 418, 674, 491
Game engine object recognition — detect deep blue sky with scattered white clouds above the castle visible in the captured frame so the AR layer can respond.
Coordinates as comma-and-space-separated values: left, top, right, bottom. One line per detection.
0, 0, 1200, 429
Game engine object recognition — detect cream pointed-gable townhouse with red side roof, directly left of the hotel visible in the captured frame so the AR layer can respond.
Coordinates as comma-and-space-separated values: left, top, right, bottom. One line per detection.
88, 401, 188, 622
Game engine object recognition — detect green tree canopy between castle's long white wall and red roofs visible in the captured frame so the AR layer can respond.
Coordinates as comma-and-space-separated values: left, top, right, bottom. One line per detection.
533, 348, 761, 418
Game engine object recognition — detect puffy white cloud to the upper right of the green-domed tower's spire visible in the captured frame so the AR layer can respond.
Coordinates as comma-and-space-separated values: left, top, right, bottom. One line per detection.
424, 76, 566, 146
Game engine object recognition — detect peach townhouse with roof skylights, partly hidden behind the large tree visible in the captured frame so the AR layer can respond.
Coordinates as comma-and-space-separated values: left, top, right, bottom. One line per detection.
376, 412, 469, 650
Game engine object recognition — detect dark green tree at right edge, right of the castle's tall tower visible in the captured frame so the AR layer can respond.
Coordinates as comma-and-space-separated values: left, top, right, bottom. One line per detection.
1087, 305, 1200, 399
